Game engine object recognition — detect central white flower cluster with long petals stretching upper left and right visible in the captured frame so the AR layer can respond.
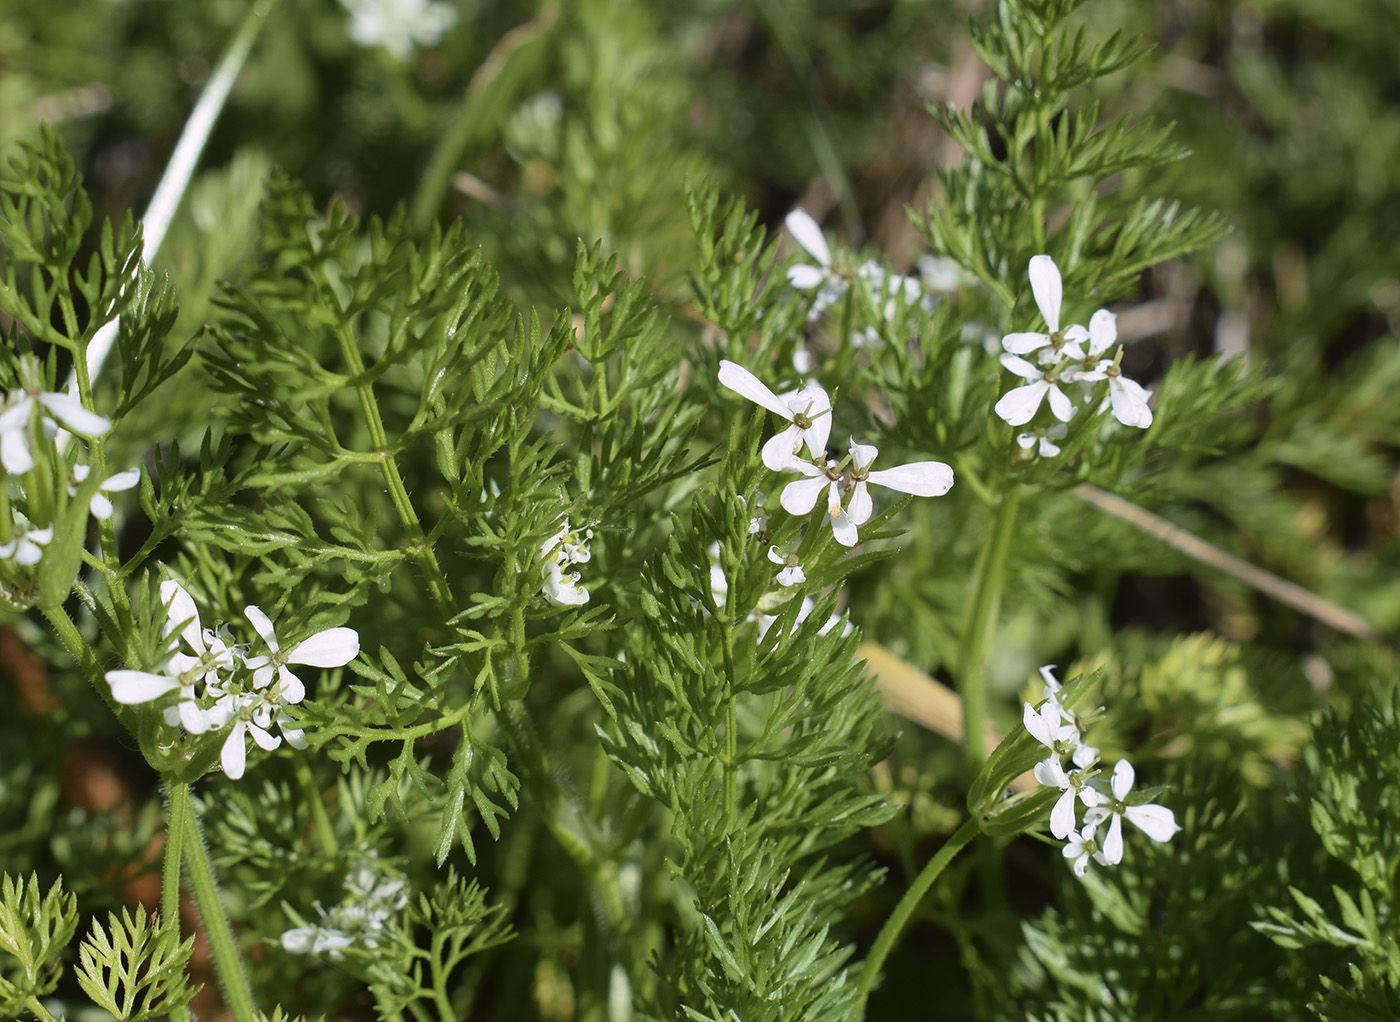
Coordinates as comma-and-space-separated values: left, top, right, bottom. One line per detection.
720, 360, 953, 560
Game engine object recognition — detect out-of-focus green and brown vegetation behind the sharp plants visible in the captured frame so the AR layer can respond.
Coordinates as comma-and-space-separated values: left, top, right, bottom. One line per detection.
8, 0, 1400, 1018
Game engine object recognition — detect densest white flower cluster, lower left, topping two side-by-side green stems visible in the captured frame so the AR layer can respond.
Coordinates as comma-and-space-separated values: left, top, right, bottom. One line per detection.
106, 580, 360, 780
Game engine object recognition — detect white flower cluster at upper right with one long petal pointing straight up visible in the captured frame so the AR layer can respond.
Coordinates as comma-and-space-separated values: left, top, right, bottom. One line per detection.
994, 255, 1152, 431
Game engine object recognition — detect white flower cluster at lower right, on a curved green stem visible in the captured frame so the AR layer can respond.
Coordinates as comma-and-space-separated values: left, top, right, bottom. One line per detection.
1022, 666, 1180, 876
